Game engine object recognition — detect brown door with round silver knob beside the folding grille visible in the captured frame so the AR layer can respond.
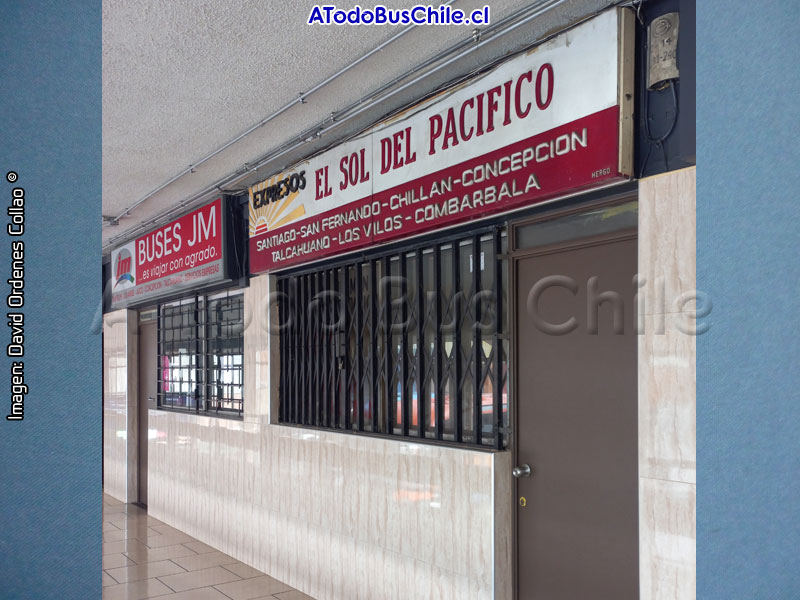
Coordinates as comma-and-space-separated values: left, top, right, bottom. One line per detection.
515, 234, 639, 600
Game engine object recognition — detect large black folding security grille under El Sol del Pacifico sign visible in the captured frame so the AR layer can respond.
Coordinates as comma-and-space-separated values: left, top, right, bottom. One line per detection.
278, 228, 509, 448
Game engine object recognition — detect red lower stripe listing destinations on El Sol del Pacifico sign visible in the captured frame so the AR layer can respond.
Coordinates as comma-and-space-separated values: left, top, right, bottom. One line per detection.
250, 106, 622, 273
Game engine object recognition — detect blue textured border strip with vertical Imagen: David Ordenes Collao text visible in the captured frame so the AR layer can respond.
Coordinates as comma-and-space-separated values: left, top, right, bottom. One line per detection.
0, 0, 102, 600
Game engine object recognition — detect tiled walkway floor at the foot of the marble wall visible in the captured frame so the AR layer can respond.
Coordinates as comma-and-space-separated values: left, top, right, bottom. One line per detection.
103, 494, 313, 600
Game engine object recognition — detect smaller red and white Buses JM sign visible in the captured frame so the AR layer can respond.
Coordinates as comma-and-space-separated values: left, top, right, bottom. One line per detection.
111, 198, 226, 308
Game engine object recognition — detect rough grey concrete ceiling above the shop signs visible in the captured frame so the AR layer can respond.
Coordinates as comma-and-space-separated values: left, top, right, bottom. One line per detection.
103, 0, 612, 252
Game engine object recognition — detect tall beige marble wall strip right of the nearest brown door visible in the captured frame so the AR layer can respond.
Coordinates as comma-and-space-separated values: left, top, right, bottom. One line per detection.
638, 167, 702, 600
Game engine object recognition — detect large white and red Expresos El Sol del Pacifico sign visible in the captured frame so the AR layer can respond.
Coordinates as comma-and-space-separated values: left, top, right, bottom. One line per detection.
250, 10, 629, 273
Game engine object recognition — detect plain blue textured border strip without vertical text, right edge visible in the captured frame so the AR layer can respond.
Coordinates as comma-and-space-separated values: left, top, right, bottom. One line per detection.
697, 0, 800, 600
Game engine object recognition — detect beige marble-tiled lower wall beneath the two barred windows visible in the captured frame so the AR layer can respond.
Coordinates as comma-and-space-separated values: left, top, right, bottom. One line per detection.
148, 411, 510, 600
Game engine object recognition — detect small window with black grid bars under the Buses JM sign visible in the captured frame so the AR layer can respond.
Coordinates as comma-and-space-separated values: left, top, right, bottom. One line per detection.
158, 292, 244, 417
